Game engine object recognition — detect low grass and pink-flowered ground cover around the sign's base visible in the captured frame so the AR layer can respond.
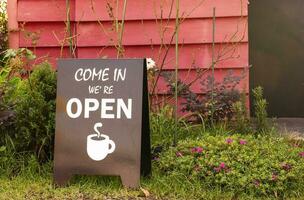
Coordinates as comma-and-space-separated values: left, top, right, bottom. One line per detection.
0, 128, 304, 199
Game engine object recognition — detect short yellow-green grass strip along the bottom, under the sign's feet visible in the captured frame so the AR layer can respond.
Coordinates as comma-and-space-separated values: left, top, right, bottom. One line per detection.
0, 166, 274, 200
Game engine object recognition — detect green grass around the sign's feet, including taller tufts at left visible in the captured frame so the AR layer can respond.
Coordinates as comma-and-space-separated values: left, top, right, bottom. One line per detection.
0, 136, 304, 200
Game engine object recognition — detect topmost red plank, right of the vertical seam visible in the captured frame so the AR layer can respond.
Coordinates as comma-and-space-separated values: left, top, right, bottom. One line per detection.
76, 0, 248, 21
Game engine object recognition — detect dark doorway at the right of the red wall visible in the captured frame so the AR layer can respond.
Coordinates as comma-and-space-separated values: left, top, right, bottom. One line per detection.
249, 0, 304, 118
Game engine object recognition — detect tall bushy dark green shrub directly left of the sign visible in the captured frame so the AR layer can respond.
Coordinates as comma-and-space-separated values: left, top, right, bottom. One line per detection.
7, 63, 56, 161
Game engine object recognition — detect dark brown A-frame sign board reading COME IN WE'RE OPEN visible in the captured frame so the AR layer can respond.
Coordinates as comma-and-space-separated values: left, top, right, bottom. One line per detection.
54, 59, 151, 188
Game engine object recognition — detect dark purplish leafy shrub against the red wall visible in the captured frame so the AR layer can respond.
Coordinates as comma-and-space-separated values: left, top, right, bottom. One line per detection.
181, 71, 245, 122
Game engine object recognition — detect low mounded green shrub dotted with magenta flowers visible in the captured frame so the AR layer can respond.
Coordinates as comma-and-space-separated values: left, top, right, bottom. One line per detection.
155, 135, 304, 197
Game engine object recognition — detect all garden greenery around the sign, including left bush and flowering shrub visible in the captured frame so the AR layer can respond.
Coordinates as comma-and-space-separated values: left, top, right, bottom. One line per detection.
0, 63, 304, 199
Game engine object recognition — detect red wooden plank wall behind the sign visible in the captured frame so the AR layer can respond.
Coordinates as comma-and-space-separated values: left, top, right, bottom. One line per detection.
8, 0, 249, 100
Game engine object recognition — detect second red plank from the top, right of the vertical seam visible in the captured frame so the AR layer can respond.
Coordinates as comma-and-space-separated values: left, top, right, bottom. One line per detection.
77, 17, 248, 47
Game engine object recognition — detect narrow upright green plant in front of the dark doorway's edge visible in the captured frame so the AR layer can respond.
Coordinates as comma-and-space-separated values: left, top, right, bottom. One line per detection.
252, 87, 269, 132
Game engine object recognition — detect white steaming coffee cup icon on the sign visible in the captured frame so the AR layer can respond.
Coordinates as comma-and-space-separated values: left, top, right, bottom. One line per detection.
87, 123, 116, 161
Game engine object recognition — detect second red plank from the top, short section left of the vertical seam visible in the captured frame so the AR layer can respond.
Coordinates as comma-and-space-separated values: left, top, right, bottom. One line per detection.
20, 22, 75, 47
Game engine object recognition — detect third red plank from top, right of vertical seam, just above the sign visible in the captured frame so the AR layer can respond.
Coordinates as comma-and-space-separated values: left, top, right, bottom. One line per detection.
78, 43, 248, 69
